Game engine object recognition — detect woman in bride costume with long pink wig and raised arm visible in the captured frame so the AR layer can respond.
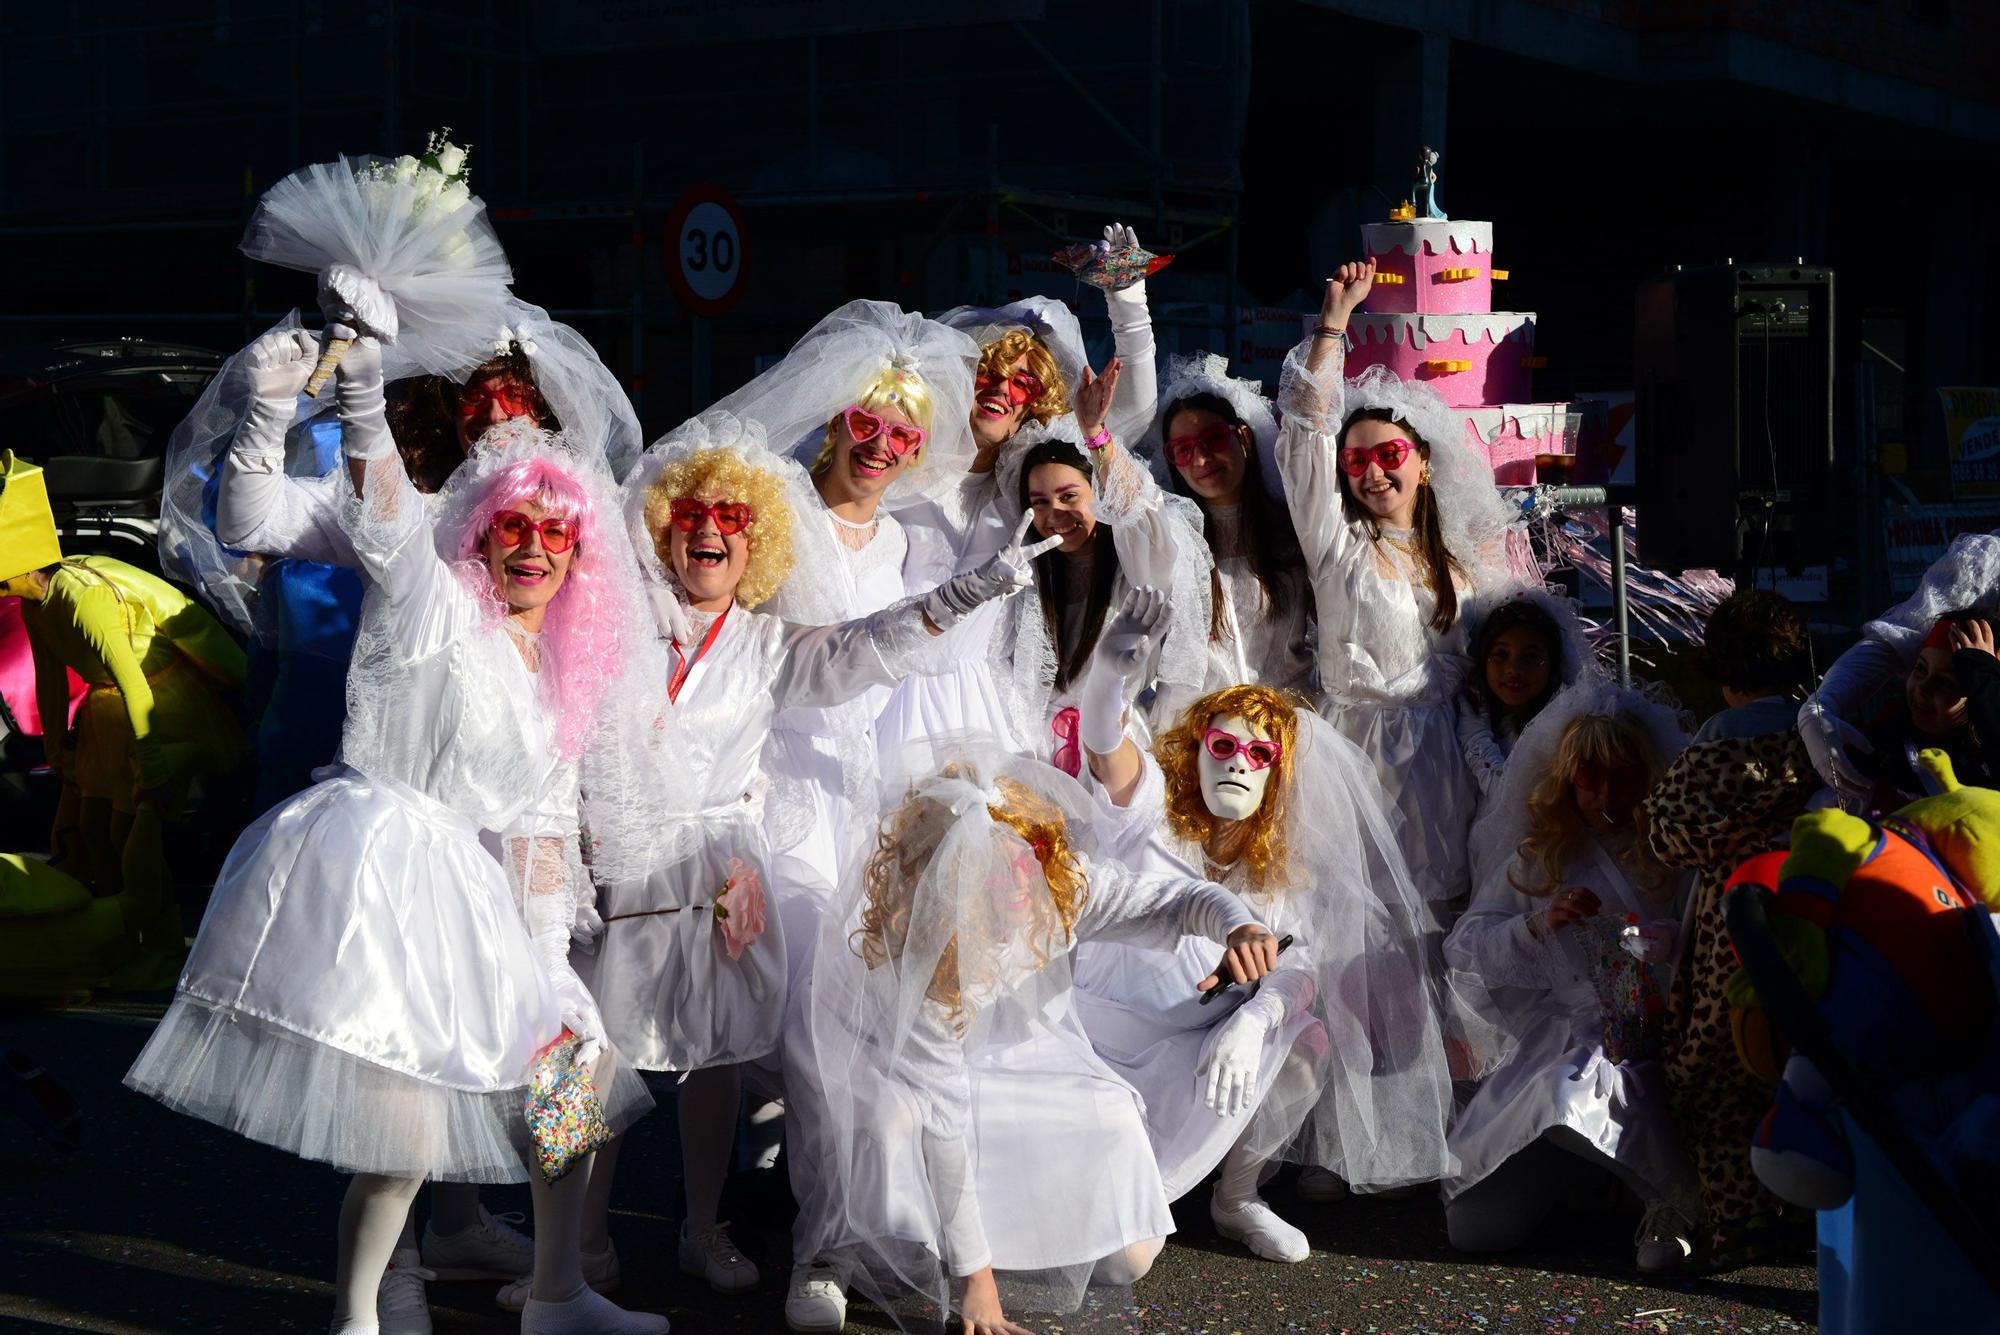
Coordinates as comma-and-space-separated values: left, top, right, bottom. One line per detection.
126, 327, 666, 1333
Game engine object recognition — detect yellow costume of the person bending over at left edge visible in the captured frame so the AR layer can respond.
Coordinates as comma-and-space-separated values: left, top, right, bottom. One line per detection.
22, 556, 244, 811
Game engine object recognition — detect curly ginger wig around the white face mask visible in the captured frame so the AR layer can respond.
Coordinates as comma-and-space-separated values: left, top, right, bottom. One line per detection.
1152, 685, 1306, 891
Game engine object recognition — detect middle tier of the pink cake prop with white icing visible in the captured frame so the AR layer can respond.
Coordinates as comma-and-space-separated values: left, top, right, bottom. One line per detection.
1346, 312, 1534, 408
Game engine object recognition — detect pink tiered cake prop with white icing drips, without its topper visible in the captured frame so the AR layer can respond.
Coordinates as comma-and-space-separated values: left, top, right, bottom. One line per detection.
1348, 195, 1594, 486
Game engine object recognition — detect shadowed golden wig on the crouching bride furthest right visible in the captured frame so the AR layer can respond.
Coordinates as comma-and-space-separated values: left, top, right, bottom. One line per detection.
1508, 713, 1670, 899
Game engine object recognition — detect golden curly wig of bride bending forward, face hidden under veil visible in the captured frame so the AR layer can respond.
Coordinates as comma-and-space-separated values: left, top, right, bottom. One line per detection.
848, 767, 1090, 1033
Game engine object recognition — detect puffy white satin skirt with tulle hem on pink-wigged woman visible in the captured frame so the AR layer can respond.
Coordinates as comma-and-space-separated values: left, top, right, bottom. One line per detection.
126, 771, 652, 1183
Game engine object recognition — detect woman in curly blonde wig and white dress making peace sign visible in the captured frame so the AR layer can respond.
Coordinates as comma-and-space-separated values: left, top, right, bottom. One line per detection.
582, 414, 1064, 1293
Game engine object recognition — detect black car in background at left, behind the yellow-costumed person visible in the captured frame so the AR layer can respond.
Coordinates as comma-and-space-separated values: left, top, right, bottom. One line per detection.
0, 338, 224, 572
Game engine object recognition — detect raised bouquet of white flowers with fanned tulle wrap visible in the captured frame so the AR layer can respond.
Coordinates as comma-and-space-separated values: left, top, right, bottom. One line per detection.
242, 130, 514, 396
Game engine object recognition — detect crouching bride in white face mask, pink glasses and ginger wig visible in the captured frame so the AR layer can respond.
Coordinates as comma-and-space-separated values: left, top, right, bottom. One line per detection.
1076, 590, 1452, 1261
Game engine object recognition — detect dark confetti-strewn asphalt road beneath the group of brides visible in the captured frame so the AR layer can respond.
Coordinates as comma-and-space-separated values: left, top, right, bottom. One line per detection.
0, 997, 1816, 1335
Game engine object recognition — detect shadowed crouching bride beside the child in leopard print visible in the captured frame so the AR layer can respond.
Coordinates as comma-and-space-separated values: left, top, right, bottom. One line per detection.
1444, 683, 1700, 1271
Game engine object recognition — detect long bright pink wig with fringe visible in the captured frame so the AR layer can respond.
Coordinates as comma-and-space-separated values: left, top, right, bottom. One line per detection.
452, 456, 622, 759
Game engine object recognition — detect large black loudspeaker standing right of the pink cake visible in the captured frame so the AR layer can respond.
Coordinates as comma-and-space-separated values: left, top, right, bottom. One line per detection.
1632, 264, 1834, 576
